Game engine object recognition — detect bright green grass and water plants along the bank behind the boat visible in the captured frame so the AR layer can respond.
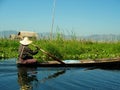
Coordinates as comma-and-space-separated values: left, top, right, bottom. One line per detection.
0, 36, 120, 60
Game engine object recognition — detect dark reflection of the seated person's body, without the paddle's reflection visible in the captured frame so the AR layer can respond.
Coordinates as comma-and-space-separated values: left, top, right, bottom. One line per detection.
18, 67, 38, 90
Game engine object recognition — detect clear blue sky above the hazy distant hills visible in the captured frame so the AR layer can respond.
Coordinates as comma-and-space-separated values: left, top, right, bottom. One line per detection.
0, 0, 120, 36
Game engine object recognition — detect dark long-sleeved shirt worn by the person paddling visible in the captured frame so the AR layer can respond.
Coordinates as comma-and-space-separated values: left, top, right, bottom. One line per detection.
19, 45, 38, 60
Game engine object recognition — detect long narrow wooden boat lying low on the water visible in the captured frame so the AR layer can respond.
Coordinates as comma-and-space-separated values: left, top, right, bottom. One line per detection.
17, 58, 120, 68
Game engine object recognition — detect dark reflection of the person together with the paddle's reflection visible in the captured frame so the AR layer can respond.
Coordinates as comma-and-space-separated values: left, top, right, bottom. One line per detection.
18, 67, 65, 90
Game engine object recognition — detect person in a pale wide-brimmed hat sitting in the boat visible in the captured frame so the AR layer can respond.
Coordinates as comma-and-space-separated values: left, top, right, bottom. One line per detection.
18, 37, 39, 64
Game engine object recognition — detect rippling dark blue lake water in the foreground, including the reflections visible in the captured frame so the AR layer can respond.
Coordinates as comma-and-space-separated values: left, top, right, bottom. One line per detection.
0, 59, 120, 90
